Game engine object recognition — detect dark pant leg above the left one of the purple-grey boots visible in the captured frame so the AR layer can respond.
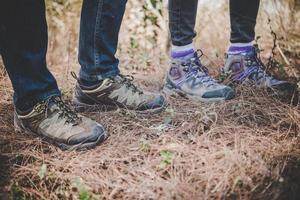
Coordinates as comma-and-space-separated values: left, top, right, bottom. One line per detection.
169, 0, 198, 46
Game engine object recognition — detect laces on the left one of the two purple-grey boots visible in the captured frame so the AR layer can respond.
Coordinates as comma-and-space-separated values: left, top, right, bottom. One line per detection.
182, 49, 216, 87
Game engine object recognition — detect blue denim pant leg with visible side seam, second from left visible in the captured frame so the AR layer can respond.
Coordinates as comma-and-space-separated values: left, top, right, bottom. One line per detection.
79, 0, 127, 81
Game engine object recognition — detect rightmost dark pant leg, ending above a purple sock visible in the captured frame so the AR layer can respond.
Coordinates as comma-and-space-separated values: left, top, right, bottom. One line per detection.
230, 0, 260, 43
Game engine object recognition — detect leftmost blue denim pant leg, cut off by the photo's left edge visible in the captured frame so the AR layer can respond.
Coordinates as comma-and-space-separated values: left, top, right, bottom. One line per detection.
0, 0, 60, 110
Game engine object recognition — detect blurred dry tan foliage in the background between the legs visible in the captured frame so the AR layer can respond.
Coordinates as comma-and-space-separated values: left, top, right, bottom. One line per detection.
1, 0, 300, 80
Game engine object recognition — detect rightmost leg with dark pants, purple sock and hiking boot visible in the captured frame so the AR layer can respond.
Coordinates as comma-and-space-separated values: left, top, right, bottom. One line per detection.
224, 0, 294, 93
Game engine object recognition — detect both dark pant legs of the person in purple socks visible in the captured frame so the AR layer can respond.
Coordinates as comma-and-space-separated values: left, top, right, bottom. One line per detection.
169, 0, 260, 46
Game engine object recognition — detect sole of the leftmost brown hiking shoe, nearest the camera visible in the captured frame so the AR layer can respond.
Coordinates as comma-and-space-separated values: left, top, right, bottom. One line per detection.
14, 113, 108, 151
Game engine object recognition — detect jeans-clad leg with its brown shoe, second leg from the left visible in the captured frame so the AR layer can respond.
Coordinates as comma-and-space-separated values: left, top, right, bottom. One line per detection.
73, 0, 165, 112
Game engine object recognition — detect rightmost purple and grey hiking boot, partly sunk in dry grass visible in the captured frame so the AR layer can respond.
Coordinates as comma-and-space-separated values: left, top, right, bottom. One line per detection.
223, 47, 295, 94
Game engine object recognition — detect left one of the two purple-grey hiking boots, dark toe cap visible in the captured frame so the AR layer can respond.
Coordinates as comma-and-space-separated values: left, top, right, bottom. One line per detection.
164, 50, 234, 102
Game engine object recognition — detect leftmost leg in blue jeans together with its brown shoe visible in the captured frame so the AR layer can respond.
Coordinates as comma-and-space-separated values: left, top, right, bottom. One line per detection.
0, 0, 105, 149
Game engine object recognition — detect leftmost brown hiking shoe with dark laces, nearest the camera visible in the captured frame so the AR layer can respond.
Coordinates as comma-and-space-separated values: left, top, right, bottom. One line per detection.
14, 97, 106, 150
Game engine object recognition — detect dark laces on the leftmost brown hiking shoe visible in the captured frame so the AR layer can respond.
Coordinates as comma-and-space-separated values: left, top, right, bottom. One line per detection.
33, 97, 81, 125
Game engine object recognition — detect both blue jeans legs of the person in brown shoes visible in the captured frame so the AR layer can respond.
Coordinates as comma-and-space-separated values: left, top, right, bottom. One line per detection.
0, 0, 126, 111
